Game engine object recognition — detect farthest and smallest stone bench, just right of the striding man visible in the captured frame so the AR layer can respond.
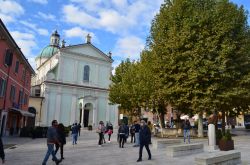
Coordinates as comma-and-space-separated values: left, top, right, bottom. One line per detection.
153, 139, 181, 149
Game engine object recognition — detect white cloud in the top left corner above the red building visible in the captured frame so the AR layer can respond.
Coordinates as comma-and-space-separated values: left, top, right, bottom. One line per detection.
0, 0, 24, 23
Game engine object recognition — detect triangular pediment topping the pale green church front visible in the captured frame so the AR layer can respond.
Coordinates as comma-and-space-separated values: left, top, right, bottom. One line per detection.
62, 44, 113, 63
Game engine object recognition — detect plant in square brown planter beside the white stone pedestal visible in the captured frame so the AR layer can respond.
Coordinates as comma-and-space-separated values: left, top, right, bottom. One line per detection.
219, 129, 234, 151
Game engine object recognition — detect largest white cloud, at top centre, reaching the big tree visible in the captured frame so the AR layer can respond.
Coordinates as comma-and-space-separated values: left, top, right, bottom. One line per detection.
63, 0, 163, 35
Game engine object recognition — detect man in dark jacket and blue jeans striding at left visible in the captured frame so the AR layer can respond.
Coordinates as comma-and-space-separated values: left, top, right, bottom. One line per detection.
42, 120, 62, 165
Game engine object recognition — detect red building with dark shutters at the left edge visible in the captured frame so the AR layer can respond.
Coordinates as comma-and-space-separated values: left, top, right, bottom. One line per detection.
0, 19, 35, 135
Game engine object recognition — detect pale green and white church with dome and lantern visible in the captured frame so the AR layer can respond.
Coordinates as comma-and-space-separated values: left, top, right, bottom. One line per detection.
30, 31, 118, 127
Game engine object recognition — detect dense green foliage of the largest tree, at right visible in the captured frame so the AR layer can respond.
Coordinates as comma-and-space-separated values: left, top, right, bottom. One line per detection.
148, 0, 250, 113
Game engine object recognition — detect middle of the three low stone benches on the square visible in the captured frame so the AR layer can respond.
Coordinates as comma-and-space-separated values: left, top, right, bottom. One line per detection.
167, 143, 204, 157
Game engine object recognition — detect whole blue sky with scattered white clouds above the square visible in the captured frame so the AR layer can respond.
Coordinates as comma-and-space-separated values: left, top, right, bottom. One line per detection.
0, 0, 250, 69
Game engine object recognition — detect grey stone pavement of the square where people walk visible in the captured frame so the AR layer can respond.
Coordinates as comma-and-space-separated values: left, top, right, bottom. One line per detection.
3, 130, 250, 165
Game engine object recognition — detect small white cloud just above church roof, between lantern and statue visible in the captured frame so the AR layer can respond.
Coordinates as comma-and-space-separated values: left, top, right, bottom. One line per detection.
63, 27, 99, 43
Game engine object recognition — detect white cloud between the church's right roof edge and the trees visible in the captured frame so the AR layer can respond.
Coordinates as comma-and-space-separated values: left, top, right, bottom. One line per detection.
114, 36, 144, 60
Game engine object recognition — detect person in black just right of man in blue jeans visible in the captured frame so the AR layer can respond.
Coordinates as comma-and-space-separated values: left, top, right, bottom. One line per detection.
55, 123, 66, 159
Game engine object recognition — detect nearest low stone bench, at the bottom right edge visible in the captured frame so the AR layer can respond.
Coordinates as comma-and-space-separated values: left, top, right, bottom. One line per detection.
195, 150, 241, 165
